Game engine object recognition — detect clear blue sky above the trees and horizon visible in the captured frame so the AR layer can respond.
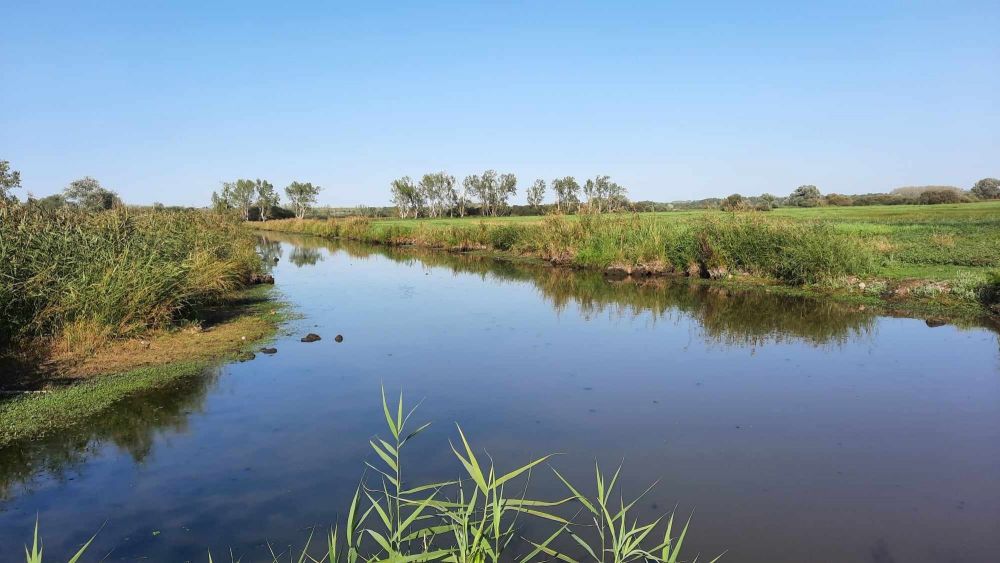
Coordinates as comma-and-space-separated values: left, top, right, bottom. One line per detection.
0, 0, 1000, 205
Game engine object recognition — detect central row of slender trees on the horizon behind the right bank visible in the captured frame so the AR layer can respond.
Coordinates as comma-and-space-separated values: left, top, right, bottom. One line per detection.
390, 169, 630, 218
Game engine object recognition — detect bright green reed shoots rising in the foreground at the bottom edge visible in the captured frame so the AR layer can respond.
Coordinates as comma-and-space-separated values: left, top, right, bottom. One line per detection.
25, 391, 721, 563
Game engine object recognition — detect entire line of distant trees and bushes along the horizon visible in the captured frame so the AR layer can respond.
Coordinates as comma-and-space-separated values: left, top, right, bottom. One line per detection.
0, 159, 1000, 221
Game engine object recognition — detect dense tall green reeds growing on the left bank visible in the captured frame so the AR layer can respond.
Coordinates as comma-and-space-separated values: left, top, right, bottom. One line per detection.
0, 206, 260, 348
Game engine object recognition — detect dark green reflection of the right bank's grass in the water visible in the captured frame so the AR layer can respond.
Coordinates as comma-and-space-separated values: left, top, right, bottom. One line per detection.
262, 234, 876, 346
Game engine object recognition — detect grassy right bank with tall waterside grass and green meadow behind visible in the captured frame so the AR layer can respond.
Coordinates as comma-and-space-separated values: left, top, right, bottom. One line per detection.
255, 202, 1000, 314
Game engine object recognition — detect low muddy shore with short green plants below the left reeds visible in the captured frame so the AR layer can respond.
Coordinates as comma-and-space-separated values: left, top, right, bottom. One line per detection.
0, 286, 288, 448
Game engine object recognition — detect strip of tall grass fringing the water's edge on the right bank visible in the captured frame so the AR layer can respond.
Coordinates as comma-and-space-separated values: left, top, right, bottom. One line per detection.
263, 213, 878, 284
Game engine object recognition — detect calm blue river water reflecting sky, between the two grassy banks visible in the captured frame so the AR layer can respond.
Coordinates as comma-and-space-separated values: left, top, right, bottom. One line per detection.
0, 232, 1000, 563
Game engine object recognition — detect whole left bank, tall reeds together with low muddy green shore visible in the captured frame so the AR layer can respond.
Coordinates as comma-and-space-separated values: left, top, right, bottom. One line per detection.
0, 205, 283, 446
